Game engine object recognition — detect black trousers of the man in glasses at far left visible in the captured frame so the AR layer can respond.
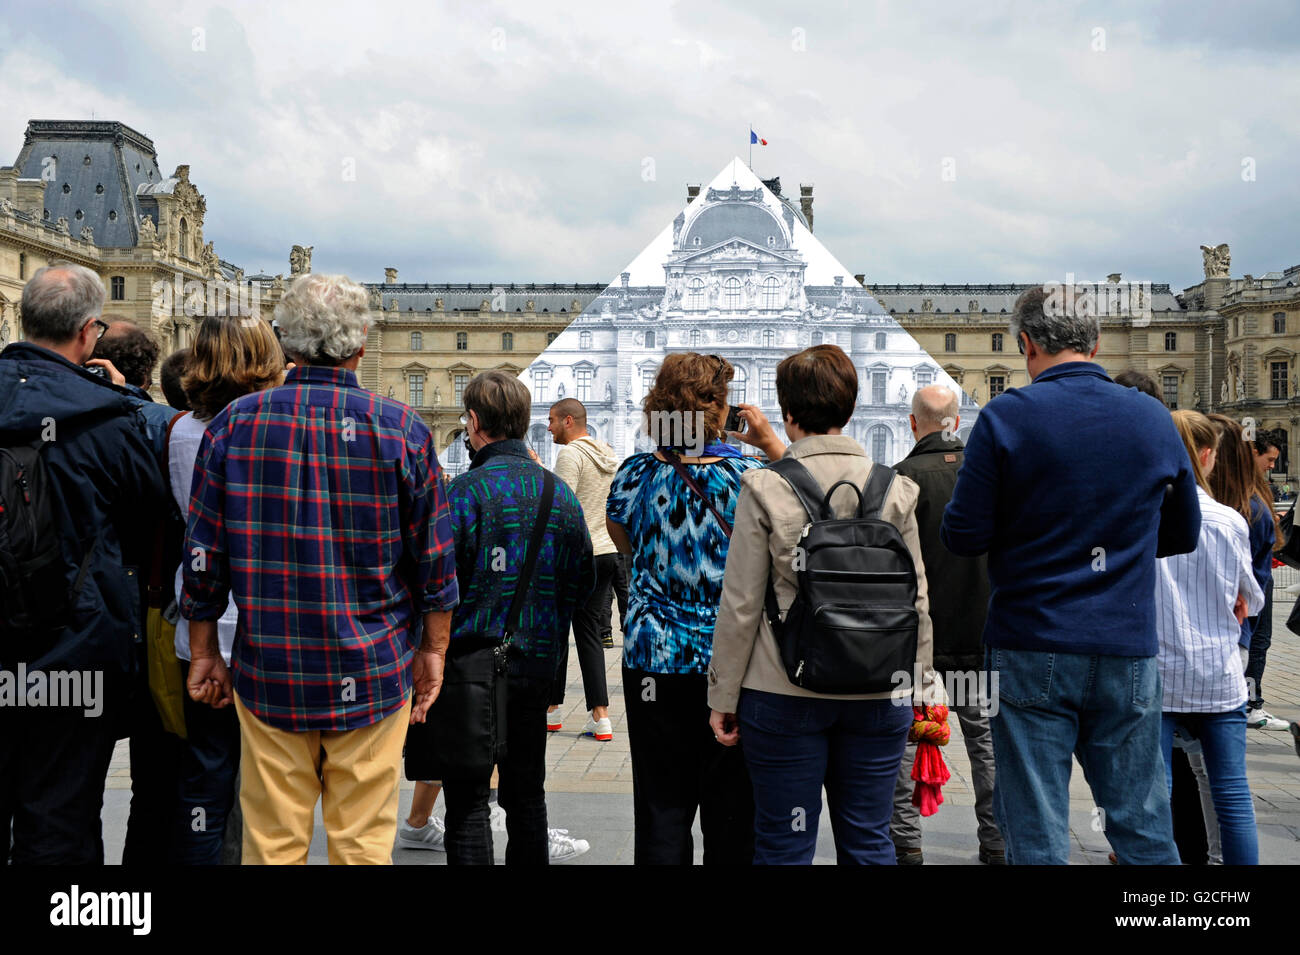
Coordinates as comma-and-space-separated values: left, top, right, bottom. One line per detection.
0, 691, 117, 865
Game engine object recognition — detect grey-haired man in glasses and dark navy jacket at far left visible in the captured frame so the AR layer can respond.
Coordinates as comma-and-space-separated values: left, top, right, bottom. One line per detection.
0, 264, 168, 864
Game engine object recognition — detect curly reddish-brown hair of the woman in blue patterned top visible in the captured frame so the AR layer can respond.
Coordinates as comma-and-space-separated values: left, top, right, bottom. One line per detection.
642, 352, 736, 447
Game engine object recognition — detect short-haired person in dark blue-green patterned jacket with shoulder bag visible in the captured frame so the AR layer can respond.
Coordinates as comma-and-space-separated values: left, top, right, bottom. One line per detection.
436, 372, 595, 865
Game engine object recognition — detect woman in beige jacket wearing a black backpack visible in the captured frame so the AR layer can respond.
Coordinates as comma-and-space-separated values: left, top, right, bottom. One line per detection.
709, 346, 937, 865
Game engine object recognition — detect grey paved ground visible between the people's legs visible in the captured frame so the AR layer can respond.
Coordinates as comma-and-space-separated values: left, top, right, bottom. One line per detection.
104, 595, 1300, 865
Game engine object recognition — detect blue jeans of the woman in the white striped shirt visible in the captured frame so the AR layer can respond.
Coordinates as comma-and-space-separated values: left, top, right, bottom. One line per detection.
1161, 706, 1260, 865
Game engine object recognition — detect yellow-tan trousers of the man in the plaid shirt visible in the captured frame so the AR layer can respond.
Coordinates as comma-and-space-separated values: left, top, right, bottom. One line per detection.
235, 694, 411, 865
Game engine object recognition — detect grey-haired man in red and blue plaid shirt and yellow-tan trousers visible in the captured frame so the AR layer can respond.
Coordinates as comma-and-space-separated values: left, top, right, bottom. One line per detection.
181, 275, 458, 864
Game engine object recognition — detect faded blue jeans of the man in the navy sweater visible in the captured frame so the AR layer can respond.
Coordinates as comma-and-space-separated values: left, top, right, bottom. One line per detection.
985, 647, 1179, 865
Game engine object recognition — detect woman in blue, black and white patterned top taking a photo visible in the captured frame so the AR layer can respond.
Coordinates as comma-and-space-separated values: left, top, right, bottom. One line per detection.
606, 352, 761, 865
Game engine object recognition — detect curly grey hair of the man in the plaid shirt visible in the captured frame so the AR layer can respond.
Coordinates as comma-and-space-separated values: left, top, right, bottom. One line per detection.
276, 273, 368, 365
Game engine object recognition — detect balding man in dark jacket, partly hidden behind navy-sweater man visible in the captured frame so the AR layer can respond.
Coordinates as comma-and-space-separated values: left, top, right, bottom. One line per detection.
889, 385, 1006, 865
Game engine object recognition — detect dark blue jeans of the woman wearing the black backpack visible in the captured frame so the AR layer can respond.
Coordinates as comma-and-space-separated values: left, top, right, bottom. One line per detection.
736, 690, 911, 865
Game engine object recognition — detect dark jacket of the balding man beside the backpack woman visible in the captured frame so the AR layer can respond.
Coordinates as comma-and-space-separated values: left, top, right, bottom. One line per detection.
894, 431, 989, 673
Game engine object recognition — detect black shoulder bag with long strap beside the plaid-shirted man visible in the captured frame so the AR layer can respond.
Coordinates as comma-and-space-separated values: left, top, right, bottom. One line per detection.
406, 468, 555, 780
